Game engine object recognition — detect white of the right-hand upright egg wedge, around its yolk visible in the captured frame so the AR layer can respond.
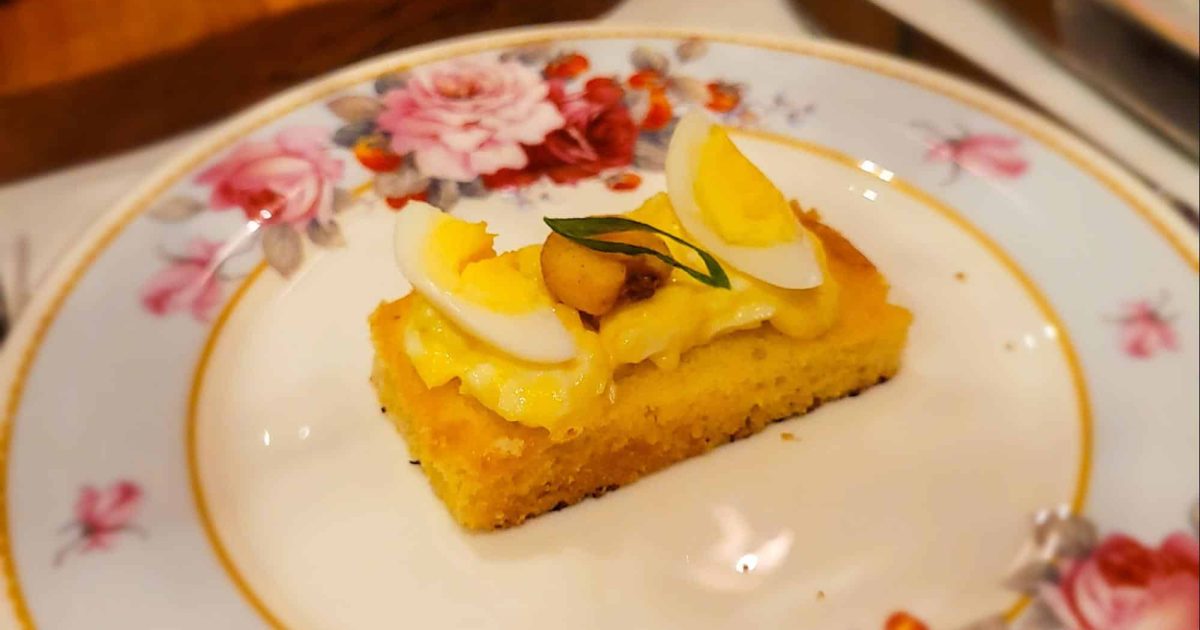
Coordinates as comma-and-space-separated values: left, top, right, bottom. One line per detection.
666, 110, 824, 289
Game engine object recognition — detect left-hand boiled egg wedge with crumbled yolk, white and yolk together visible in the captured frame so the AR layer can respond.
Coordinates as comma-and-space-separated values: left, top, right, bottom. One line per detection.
395, 200, 576, 364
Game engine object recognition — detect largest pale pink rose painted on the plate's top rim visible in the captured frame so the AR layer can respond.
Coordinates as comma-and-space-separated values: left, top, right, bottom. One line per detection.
377, 58, 565, 182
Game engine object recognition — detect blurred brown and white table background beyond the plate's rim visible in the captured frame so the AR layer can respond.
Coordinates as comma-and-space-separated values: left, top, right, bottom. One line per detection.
0, 0, 1200, 335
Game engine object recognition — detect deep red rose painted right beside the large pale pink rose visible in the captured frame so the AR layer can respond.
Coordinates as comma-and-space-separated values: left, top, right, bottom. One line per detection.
484, 78, 637, 188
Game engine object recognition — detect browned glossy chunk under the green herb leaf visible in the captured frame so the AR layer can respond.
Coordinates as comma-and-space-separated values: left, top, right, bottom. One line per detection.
541, 232, 671, 317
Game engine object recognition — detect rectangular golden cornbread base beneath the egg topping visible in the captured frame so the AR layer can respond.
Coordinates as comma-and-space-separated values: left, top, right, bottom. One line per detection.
371, 215, 912, 529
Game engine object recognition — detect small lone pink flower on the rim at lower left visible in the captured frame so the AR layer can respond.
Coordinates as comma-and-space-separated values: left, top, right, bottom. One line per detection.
54, 480, 145, 566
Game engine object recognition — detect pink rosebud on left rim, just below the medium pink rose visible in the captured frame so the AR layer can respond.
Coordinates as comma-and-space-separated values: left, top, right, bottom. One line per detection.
142, 238, 222, 322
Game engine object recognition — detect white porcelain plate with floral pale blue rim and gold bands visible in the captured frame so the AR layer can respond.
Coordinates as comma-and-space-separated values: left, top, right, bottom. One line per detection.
0, 28, 1200, 629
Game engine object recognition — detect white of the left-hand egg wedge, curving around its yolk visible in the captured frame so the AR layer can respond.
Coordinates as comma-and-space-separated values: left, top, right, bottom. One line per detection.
395, 200, 577, 364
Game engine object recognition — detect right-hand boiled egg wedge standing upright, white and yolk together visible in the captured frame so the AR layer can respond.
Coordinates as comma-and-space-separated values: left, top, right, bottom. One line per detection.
666, 110, 824, 289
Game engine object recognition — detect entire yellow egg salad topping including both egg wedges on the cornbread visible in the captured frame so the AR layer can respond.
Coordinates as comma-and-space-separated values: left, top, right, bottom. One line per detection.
396, 114, 838, 434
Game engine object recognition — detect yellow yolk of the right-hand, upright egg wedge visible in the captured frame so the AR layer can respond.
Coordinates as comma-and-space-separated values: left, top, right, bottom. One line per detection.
692, 125, 799, 247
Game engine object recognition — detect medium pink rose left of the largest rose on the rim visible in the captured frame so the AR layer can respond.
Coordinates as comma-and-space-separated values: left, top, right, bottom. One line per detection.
196, 127, 342, 228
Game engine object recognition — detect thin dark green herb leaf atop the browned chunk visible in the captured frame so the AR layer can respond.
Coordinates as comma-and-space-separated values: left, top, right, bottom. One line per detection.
544, 216, 730, 289
